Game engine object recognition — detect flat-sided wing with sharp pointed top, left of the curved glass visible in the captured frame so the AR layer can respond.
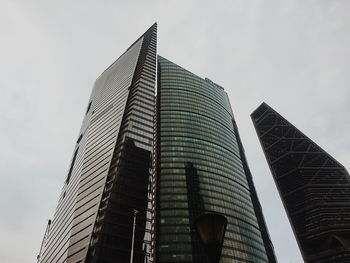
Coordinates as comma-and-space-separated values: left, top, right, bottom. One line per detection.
39, 24, 157, 263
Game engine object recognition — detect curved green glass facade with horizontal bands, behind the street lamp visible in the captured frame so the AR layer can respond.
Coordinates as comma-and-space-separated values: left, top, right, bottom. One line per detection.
156, 56, 269, 263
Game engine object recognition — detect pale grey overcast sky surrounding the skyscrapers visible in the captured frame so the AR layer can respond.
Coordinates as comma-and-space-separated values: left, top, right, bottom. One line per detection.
0, 0, 350, 263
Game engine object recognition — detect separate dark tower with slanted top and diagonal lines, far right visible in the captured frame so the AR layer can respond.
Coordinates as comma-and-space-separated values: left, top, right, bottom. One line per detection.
251, 103, 350, 263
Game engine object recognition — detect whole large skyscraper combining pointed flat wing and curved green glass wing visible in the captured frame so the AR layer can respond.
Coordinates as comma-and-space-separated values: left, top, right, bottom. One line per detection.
39, 24, 276, 263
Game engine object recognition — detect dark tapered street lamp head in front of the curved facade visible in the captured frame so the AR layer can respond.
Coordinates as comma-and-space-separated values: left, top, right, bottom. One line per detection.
194, 213, 227, 263
